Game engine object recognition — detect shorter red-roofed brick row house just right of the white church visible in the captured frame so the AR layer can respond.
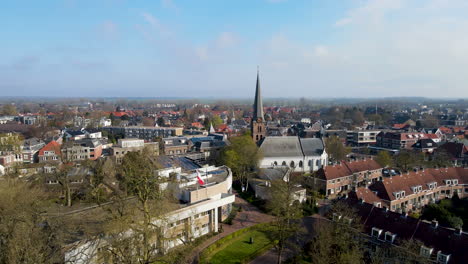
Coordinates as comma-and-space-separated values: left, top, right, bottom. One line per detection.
313, 159, 383, 198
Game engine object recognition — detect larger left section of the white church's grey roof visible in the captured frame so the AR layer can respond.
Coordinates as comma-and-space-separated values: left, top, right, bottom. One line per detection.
260, 137, 303, 157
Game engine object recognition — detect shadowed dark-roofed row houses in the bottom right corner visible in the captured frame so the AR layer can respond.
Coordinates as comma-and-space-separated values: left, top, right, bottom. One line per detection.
340, 197, 468, 264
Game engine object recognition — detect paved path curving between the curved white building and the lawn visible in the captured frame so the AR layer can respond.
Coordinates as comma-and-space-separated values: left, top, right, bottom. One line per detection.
188, 193, 273, 264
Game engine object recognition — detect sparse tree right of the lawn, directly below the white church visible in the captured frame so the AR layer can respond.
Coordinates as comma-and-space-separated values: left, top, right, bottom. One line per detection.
267, 175, 302, 264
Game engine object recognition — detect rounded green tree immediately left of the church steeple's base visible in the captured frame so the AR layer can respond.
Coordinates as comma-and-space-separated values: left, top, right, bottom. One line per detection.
220, 134, 261, 190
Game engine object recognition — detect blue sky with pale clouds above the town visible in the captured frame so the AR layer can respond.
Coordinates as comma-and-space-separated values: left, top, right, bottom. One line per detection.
0, 0, 468, 99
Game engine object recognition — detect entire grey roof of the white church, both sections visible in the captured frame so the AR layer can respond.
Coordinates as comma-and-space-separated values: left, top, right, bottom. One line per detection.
260, 136, 325, 157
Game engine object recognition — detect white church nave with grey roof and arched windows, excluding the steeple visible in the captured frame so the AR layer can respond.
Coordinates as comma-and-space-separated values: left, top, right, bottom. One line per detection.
260, 136, 328, 172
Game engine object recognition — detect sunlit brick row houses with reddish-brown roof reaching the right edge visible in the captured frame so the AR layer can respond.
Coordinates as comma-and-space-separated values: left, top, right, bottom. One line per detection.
350, 167, 468, 212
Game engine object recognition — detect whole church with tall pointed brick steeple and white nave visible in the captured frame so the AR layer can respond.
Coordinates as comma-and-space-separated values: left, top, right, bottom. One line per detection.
251, 70, 328, 172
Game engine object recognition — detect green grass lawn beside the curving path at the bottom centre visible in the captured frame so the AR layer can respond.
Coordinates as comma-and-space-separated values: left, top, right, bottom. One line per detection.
207, 230, 273, 264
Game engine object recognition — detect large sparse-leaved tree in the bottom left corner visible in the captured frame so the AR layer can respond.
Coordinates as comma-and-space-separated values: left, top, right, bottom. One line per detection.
0, 179, 61, 264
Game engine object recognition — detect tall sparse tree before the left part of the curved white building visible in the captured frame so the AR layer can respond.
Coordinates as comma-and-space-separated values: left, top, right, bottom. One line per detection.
103, 151, 173, 264
